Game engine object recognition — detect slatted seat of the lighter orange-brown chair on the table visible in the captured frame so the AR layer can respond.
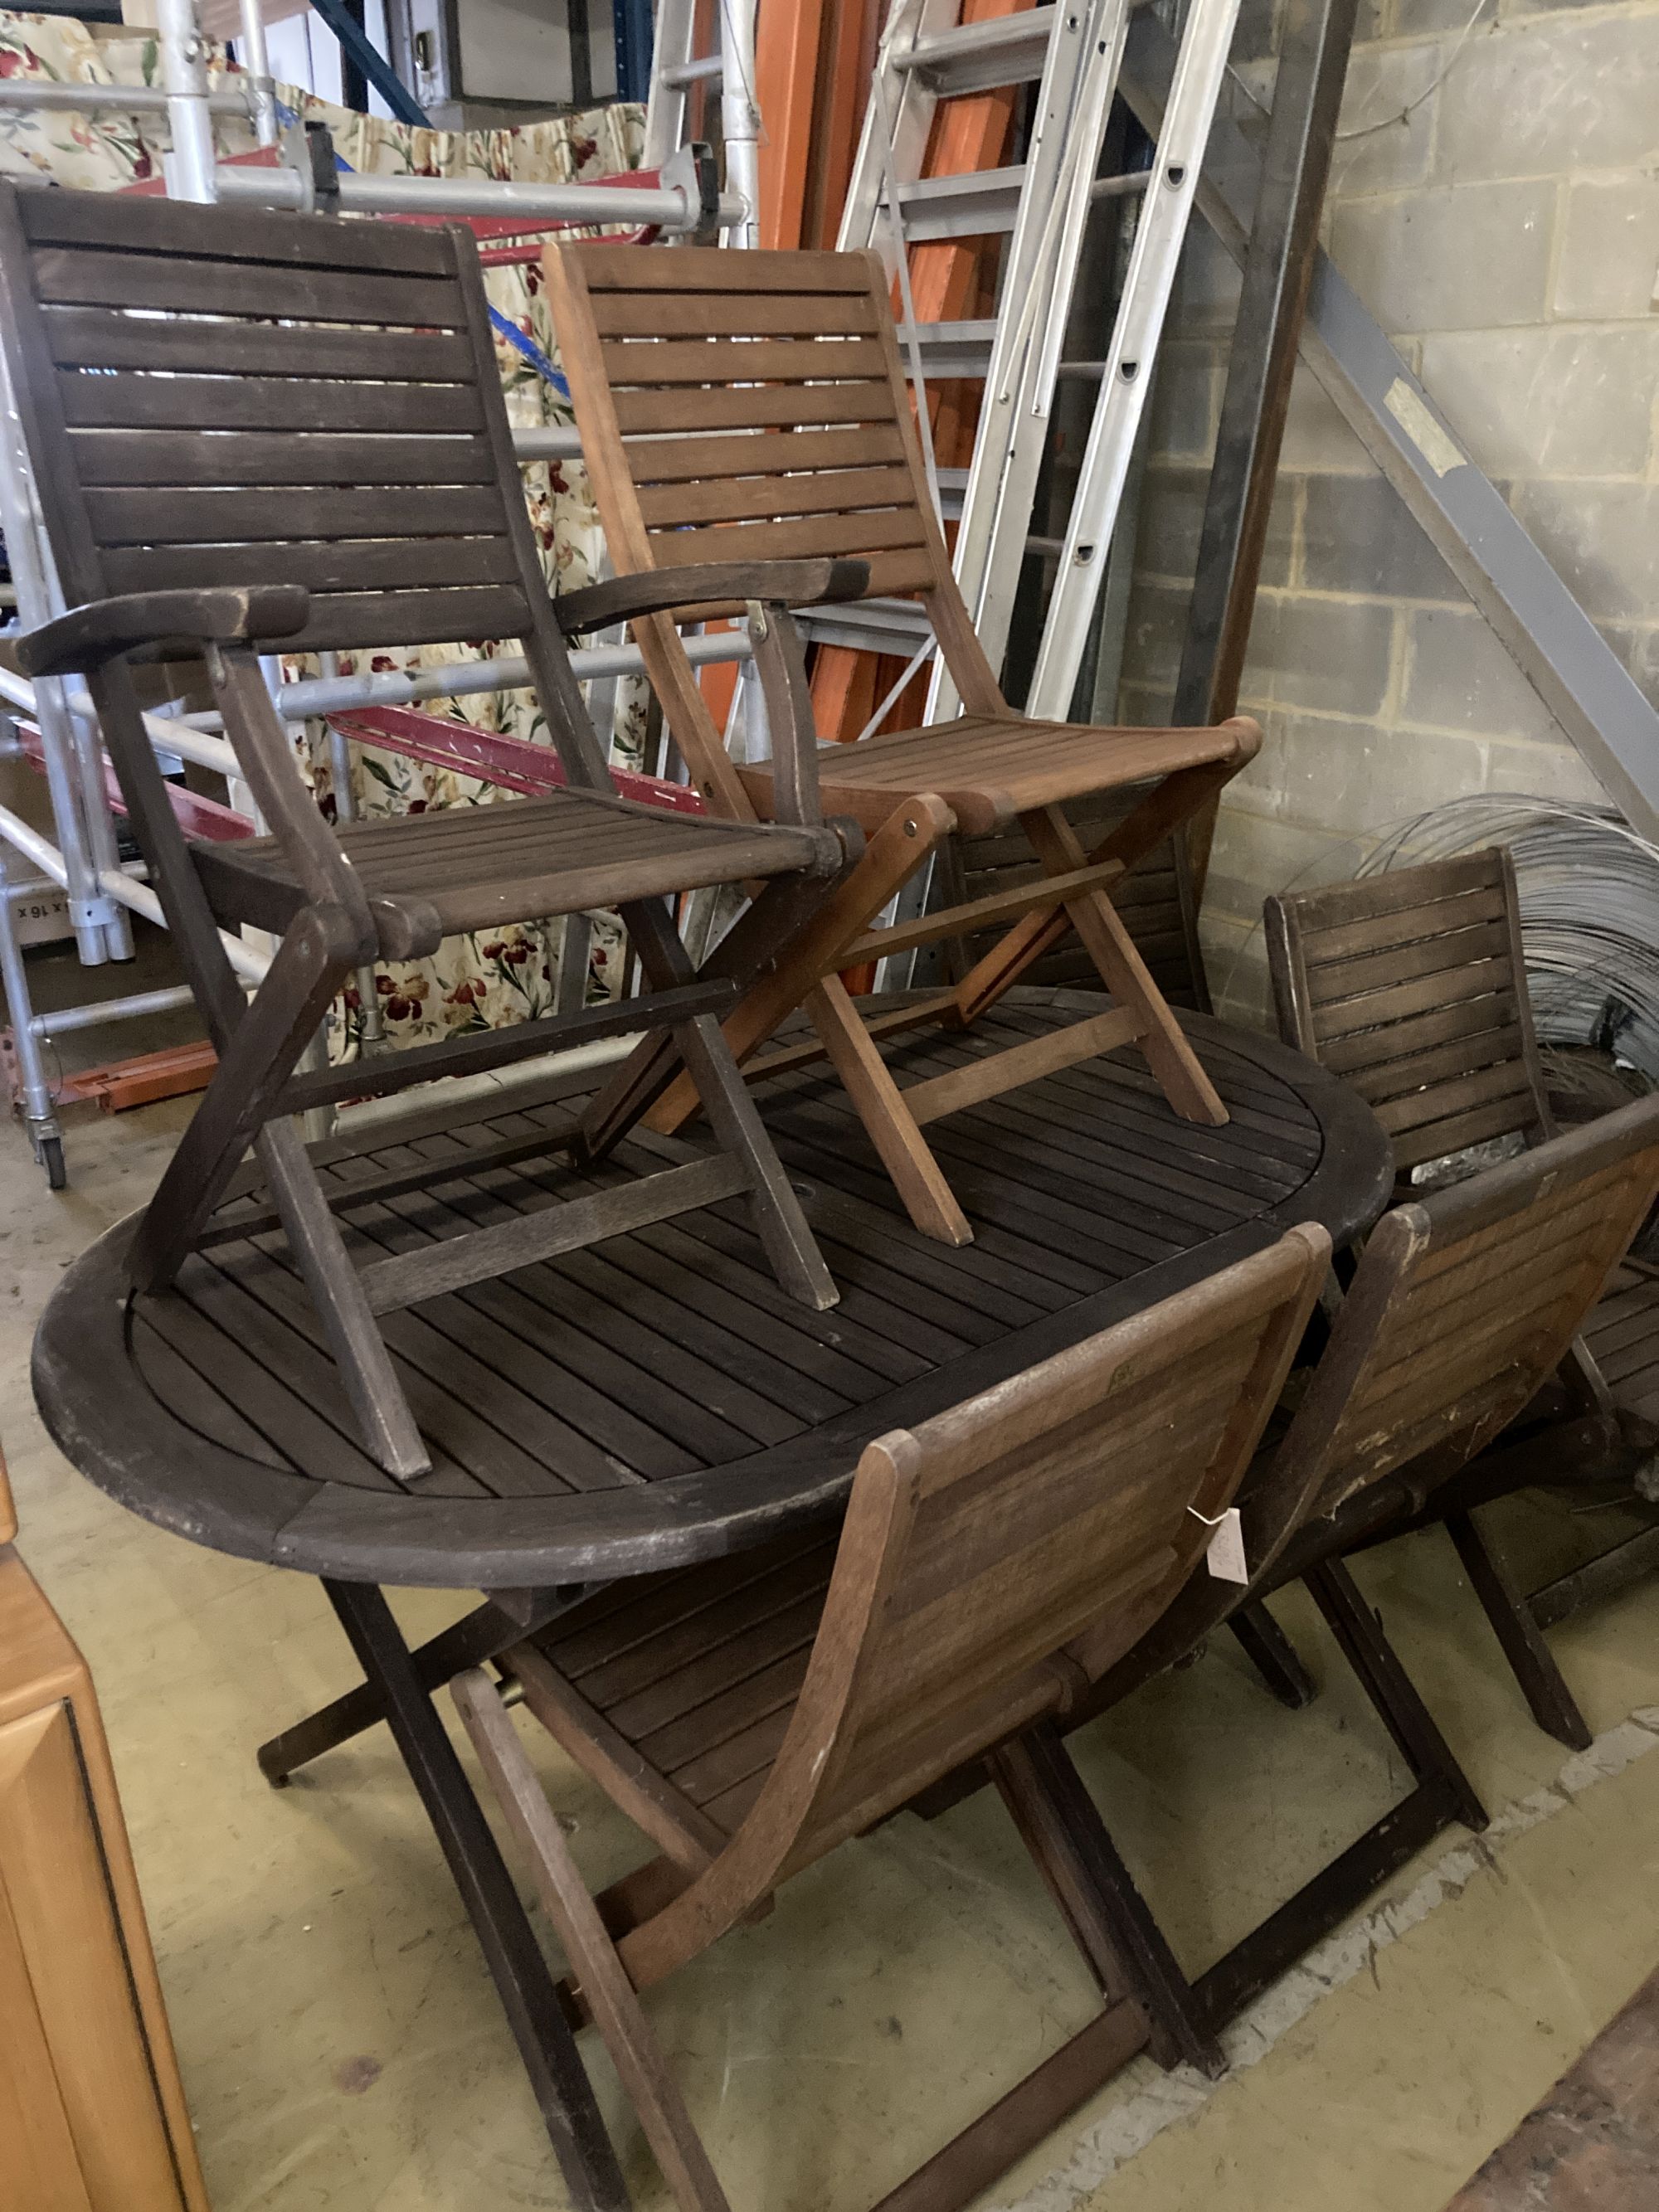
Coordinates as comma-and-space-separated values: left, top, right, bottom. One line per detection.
737, 714, 1238, 836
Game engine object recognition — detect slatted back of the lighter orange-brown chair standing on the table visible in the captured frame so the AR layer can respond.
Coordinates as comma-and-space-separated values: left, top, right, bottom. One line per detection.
547, 246, 1005, 816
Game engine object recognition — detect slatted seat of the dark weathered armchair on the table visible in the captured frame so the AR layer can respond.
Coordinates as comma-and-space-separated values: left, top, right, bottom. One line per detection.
192, 792, 823, 960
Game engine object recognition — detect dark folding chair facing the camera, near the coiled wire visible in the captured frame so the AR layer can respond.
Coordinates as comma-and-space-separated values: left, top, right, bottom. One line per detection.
1265, 847, 1659, 1750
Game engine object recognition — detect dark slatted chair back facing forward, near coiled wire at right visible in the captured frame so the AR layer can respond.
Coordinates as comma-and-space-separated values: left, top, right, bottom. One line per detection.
1265, 847, 1555, 1177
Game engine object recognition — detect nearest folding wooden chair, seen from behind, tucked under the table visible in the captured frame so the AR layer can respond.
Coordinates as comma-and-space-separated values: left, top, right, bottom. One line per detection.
455, 1228, 1330, 2212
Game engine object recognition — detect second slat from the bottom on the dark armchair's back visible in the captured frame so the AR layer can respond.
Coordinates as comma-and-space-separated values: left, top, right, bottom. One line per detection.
104, 537, 518, 591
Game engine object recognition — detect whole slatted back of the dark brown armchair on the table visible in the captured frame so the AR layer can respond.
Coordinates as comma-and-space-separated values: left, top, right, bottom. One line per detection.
0, 188, 575, 653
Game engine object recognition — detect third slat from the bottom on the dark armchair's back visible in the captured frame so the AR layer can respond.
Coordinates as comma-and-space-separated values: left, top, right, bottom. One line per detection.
86, 484, 502, 547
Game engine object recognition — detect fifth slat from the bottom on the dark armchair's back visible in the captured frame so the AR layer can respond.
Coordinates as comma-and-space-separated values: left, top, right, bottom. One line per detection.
57, 369, 484, 435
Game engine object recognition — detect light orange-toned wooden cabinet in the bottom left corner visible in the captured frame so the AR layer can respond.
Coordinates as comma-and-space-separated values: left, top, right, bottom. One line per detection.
0, 1466, 208, 2212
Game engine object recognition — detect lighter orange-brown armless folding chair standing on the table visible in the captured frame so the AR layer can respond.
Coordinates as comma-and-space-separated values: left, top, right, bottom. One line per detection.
547, 246, 1261, 1243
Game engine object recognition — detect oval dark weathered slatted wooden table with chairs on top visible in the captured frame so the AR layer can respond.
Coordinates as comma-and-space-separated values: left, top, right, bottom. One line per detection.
36, 991, 1394, 2212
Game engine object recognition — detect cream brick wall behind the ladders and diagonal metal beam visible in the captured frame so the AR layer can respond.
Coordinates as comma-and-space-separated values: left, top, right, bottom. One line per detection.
1121, 0, 1659, 1018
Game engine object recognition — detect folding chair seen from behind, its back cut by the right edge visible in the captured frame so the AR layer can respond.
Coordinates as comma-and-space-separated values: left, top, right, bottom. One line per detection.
1064, 1097, 1659, 2035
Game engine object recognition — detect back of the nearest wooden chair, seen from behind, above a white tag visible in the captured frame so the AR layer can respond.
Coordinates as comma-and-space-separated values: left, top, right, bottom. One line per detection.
732, 1228, 1330, 1867
